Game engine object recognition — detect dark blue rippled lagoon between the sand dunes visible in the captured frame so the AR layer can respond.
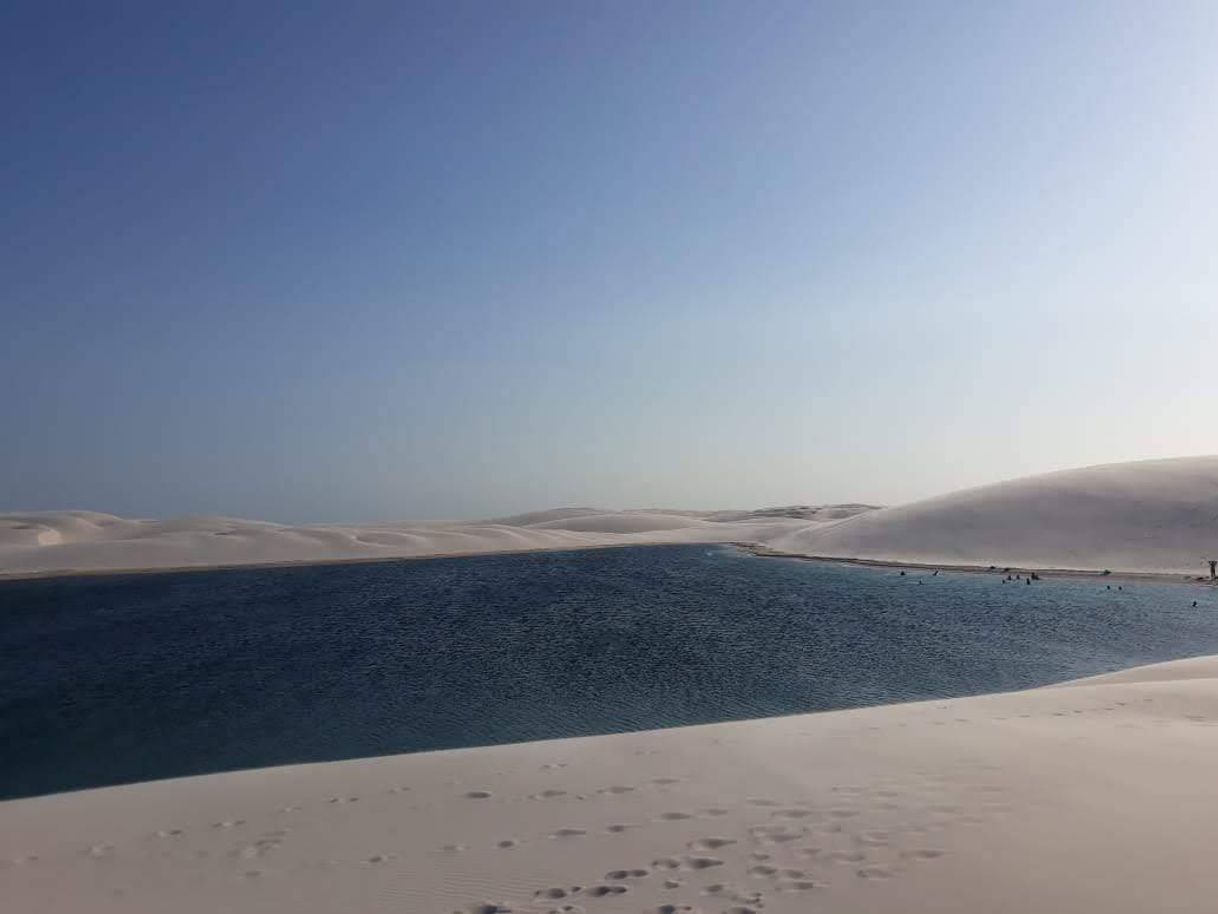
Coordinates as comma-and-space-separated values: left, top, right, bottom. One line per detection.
0, 546, 1218, 797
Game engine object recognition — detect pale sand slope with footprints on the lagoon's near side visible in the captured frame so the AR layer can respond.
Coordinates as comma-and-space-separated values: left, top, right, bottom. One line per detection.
0, 657, 1218, 914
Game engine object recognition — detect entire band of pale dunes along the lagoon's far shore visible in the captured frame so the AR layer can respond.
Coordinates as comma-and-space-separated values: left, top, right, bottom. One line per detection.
0, 457, 1218, 575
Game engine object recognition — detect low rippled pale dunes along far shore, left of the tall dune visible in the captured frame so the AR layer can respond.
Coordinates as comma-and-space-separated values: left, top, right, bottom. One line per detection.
0, 508, 857, 575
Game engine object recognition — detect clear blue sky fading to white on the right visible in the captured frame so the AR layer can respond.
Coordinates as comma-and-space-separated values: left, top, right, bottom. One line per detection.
0, 0, 1218, 522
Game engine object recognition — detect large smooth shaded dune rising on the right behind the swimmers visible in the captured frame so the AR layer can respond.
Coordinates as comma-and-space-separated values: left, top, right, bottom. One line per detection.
766, 457, 1218, 574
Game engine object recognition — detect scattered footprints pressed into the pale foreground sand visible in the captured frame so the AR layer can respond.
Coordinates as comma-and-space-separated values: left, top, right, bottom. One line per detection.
14, 765, 1005, 914
